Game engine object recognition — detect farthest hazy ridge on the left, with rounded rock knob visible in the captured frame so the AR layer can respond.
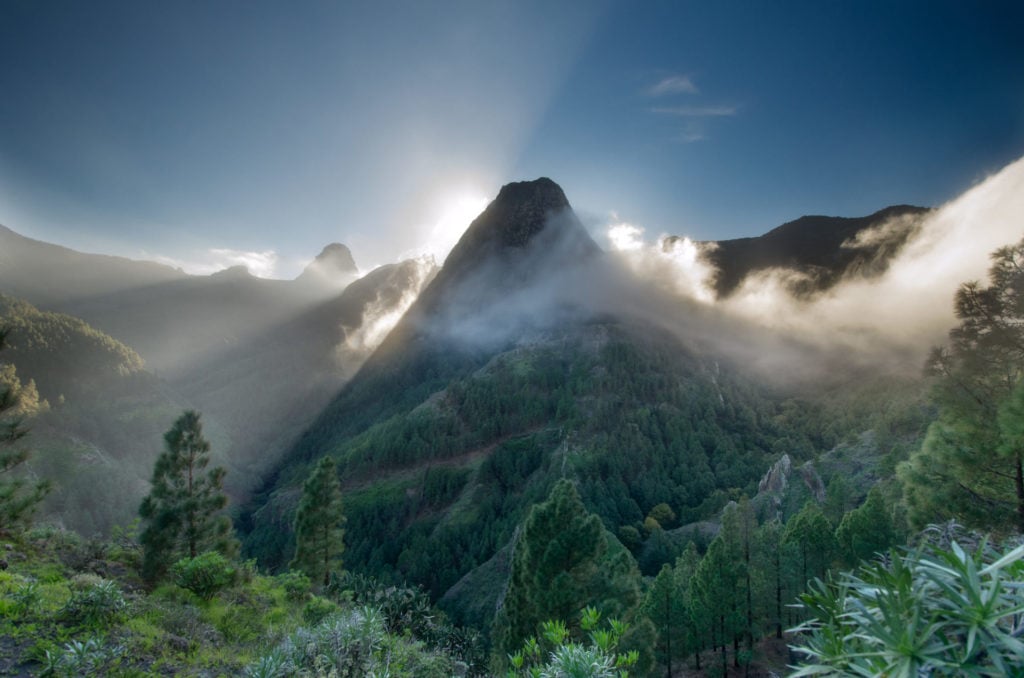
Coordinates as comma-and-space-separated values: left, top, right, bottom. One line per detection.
0, 226, 357, 377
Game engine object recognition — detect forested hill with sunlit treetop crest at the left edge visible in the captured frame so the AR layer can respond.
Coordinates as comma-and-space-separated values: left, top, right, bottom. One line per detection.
0, 295, 190, 536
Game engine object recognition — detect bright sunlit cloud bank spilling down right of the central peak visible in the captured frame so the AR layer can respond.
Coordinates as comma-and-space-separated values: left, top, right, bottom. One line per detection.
608, 153, 1024, 373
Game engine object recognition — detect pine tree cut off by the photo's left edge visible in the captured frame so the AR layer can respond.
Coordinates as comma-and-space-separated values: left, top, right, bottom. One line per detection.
0, 330, 50, 532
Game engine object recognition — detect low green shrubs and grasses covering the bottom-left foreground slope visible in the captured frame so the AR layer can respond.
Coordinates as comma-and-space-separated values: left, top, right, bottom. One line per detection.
0, 527, 482, 677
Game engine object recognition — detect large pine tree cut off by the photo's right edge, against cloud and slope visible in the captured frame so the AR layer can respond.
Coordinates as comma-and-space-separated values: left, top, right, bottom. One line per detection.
900, 242, 1024, 532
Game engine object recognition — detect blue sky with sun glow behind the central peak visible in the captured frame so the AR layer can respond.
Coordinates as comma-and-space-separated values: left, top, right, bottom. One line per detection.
0, 0, 1024, 277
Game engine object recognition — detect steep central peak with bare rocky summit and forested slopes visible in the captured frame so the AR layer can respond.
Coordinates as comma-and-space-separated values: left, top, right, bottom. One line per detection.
241, 179, 923, 647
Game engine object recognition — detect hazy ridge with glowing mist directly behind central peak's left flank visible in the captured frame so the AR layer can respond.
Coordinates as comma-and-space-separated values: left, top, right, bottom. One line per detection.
171, 260, 436, 493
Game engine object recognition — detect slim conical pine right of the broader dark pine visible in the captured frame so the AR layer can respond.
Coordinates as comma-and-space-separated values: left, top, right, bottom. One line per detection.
289, 457, 345, 586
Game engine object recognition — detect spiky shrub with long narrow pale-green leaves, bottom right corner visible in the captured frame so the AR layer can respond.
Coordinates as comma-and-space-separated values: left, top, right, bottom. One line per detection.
793, 542, 1024, 676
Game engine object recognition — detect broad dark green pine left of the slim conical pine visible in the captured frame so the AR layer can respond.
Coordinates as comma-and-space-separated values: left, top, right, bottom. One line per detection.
139, 410, 238, 582
